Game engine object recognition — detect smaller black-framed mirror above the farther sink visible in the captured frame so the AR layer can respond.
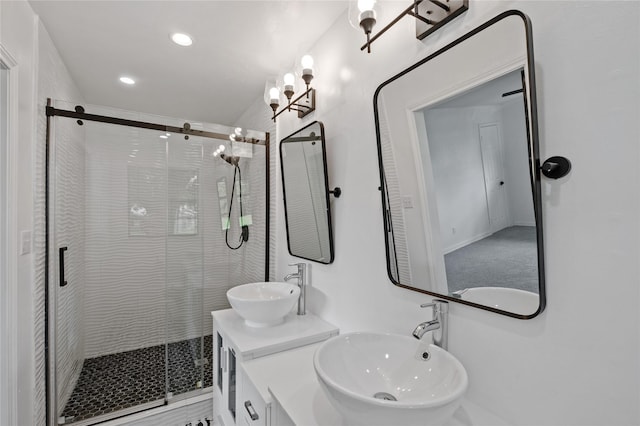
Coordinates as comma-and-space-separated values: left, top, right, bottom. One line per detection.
280, 121, 334, 264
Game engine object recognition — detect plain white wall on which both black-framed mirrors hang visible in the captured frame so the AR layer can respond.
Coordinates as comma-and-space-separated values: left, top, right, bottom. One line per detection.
265, 1, 640, 425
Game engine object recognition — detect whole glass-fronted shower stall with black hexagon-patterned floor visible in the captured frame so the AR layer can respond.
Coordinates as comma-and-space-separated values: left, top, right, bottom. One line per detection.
46, 101, 269, 426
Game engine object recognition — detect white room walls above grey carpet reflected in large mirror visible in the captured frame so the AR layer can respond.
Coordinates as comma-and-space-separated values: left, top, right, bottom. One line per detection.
422, 100, 535, 253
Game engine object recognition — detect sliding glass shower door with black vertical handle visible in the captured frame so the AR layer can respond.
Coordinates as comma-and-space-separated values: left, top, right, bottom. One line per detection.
52, 111, 167, 423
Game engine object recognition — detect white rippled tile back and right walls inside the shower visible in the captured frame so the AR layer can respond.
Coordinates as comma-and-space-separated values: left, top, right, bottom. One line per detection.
86, 116, 266, 357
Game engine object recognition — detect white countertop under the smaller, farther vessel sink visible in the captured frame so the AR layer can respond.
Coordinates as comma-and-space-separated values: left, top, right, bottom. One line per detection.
211, 309, 339, 360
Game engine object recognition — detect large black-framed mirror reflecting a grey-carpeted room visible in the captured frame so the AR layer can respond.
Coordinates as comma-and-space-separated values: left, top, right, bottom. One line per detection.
374, 11, 545, 319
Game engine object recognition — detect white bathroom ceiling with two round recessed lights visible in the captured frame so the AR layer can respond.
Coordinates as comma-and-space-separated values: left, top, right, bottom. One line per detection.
30, 0, 347, 125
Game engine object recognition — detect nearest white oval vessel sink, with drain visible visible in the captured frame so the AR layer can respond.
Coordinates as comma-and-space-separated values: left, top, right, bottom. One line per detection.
313, 333, 468, 426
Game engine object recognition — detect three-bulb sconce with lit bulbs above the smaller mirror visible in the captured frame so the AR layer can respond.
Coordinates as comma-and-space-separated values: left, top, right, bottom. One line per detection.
265, 55, 316, 122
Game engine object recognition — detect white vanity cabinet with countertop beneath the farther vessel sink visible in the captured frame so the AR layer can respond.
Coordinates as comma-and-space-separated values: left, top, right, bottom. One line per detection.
211, 309, 338, 426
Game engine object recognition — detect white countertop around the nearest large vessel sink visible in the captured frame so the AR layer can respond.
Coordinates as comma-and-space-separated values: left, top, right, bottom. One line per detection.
243, 343, 508, 426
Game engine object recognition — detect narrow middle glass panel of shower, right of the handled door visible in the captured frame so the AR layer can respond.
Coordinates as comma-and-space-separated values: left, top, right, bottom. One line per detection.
165, 134, 205, 401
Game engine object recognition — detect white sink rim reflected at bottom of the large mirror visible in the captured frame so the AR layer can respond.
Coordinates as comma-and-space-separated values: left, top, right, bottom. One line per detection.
460, 287, 540, 315
